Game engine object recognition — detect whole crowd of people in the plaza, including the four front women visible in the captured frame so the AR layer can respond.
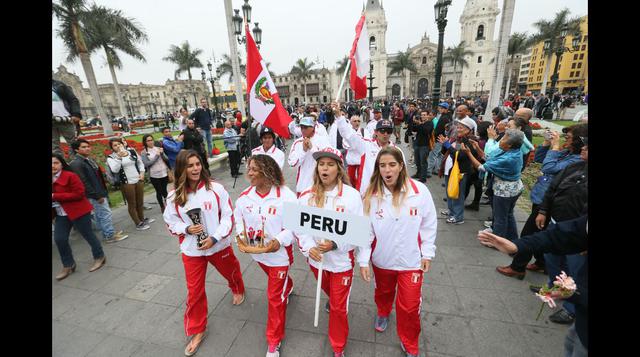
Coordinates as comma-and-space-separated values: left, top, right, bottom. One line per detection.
52, 77, 588, 357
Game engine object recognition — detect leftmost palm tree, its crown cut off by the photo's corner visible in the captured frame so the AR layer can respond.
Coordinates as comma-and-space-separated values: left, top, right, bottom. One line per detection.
51, 0, 113, 136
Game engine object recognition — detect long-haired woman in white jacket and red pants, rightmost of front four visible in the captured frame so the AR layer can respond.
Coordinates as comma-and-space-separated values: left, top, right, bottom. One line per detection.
361, 147, 437, 357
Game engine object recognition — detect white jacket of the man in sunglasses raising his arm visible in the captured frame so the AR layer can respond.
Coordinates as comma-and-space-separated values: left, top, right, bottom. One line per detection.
336, 117, 407, 195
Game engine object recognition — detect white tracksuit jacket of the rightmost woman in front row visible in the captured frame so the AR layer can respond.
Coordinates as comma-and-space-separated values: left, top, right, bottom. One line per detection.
363, 179, 438, 270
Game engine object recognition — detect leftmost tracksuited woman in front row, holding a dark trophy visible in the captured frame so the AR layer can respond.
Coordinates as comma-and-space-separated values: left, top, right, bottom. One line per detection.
162, 150, 244, 356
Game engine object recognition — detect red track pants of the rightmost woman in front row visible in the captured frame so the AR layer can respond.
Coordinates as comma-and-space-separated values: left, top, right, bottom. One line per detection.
373, 265, 423, 355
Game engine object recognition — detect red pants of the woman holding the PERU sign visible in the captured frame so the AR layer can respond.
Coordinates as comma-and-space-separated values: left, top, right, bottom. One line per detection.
309, 265, 353, 352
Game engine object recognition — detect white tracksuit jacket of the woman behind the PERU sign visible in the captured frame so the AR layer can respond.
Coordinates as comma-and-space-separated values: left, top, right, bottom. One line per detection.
295, 185, 371, 273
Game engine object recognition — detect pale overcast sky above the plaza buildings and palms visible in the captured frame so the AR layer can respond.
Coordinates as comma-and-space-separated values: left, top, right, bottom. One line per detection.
51, 0, 587, 88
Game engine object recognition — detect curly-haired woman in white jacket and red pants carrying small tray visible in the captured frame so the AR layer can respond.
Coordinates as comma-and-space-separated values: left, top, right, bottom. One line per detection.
234, 155, 296, 357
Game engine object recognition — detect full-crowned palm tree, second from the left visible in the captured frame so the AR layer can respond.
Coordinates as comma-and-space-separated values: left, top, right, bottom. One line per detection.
86, 4, 148, 116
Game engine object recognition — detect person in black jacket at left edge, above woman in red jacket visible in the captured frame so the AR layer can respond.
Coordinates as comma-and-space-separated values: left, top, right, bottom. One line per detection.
51, 79, 82, 156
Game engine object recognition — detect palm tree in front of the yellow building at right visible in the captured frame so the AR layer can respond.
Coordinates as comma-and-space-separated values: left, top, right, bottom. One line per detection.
528, 8, 580, 93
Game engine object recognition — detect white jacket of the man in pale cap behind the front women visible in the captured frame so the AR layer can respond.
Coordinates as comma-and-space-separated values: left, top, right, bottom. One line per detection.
289, 132, 330, 193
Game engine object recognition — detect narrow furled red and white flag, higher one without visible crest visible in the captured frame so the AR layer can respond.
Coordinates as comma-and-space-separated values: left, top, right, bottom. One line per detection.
349, 12, 371, 99
